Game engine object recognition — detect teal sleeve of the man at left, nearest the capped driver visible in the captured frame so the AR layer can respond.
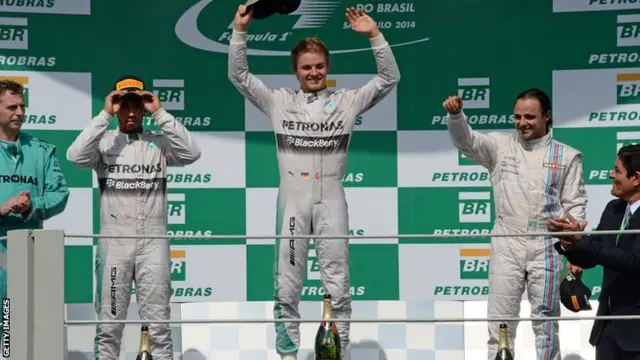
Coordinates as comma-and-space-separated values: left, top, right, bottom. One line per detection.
23, 145, 69, 221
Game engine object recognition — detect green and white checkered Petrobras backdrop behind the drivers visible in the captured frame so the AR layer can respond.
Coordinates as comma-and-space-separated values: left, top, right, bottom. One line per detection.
0, 0, 640, 303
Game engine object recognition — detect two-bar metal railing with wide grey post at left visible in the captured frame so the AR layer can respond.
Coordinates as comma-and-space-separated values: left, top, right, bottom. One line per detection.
3, 230, 640, 360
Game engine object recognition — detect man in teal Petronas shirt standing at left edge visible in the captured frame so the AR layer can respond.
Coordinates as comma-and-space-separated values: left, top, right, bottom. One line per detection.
0, 80, 69, 298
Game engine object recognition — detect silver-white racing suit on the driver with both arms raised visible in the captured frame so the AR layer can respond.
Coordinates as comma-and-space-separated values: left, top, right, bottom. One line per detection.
229, 31, 400, 355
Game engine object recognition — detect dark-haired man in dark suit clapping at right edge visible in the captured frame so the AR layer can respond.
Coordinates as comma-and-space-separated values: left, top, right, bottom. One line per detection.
547, 145, 640, 360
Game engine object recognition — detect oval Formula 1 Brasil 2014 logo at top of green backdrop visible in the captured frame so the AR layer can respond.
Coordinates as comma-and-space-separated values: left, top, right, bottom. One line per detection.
175, 0, 429, 56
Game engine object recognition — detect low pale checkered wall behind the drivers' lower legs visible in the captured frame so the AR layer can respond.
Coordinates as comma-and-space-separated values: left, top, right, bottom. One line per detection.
62, 301, 598, 360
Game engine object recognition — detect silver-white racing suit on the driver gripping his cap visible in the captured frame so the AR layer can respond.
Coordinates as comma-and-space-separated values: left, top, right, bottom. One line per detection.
67, 109, 200, 360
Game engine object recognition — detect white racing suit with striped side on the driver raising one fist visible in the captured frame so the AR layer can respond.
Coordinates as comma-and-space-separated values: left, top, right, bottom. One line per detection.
447, 113, 587, 360
